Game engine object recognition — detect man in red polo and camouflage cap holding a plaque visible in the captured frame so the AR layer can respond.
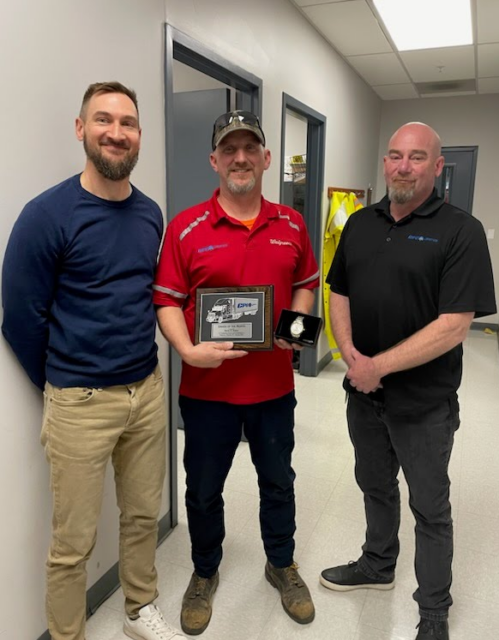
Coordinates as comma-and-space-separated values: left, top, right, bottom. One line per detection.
154, 111, 319, 635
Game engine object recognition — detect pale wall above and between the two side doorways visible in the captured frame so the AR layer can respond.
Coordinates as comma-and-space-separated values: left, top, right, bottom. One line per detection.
165, 0, 381, 359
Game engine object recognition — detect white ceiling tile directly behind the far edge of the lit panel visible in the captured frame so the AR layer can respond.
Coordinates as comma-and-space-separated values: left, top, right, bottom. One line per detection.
400, 46, 475, 82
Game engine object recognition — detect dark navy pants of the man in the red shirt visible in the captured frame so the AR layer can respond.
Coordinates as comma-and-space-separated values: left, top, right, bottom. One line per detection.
179, 392, 296, 578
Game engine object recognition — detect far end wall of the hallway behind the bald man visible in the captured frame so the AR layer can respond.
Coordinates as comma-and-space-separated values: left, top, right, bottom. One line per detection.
376, 94, 499, 324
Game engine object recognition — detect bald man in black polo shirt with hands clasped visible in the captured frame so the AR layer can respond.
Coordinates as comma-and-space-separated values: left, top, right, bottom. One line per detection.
320, 123, 496, 640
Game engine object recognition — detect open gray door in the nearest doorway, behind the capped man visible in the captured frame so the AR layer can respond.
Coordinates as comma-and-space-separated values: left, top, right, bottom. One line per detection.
168, 89, 230, 429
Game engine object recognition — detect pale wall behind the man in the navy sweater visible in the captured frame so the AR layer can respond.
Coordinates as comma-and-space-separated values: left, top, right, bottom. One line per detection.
0, 0, 169, 640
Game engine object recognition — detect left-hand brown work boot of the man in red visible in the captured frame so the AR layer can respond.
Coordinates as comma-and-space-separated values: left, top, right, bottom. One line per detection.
180, 571, 219, 636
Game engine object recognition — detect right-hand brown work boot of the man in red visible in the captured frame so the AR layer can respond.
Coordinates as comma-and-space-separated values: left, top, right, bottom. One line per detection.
265, 562, 315, 624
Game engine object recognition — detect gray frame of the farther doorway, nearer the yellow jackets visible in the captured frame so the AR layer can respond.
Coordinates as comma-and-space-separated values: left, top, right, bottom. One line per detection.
279, 93, 327, 377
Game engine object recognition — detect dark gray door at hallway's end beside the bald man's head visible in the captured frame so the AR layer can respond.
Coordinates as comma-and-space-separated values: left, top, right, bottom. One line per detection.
435, 147, 478, 214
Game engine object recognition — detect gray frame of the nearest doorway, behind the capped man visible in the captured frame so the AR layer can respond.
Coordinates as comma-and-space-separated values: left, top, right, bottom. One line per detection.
164, 23, 263, 528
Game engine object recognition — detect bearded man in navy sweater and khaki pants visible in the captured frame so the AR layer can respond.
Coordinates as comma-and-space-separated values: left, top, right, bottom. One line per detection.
2, 82, 188, 640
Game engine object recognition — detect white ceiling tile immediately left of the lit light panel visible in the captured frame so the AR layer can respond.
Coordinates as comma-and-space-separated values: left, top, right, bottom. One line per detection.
303, 0, 392, 56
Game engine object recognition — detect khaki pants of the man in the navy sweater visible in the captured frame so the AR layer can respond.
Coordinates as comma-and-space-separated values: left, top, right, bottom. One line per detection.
41, 367, 166, 640
